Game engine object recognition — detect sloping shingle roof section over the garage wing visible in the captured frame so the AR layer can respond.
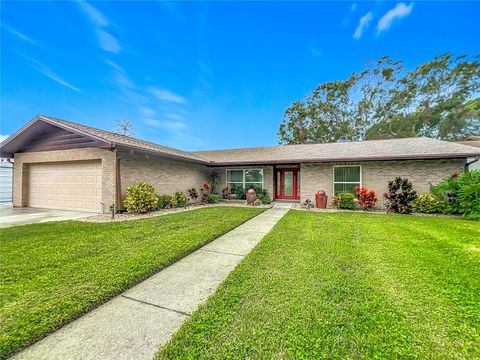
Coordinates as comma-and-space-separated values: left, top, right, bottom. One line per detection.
38, 115, 208, 162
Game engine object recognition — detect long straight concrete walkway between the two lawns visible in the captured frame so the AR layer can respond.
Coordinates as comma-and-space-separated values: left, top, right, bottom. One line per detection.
15, 207, 289, 360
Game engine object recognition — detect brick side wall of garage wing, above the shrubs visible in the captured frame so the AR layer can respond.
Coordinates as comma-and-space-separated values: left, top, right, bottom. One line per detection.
118, 153, 208, 205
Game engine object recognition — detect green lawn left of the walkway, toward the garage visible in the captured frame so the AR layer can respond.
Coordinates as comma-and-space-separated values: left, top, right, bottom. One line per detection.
0, 207, 263, 358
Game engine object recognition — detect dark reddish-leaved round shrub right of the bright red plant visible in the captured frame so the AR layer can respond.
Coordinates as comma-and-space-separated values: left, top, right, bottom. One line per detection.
383, 177, 417, 214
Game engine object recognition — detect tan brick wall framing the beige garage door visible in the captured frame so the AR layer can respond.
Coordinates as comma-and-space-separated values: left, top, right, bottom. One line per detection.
13, 147, 116, 208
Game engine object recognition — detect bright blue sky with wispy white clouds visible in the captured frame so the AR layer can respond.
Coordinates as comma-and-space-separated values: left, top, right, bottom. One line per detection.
0, 1, 480, 150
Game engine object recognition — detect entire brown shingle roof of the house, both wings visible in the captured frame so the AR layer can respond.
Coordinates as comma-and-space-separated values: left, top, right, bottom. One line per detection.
0, 115, 480, 165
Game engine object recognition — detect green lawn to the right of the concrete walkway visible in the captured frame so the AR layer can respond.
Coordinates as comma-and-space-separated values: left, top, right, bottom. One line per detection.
157, 211, 480, 359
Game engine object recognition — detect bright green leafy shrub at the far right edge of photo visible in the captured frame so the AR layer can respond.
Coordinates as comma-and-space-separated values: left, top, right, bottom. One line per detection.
432, 170, 480, 220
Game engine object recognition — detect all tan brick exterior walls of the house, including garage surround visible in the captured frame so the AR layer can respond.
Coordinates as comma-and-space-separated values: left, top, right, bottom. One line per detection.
13, 147, 466, 209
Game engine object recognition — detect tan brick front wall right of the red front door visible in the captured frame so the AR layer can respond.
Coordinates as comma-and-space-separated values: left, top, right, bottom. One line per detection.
300, 159, 466, 208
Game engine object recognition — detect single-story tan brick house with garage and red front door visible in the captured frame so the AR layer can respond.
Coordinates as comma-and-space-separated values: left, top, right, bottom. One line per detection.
0, 115, 480, 212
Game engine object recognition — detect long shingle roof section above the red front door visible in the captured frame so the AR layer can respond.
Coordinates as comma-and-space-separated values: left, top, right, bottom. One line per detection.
194, 137, 480, 165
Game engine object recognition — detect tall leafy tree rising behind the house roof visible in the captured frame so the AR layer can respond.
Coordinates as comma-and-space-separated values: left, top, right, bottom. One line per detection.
278, 53, 480, 144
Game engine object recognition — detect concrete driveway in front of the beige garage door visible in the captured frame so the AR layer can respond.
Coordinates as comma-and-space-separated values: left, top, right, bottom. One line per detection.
0, 205, 95, 228
